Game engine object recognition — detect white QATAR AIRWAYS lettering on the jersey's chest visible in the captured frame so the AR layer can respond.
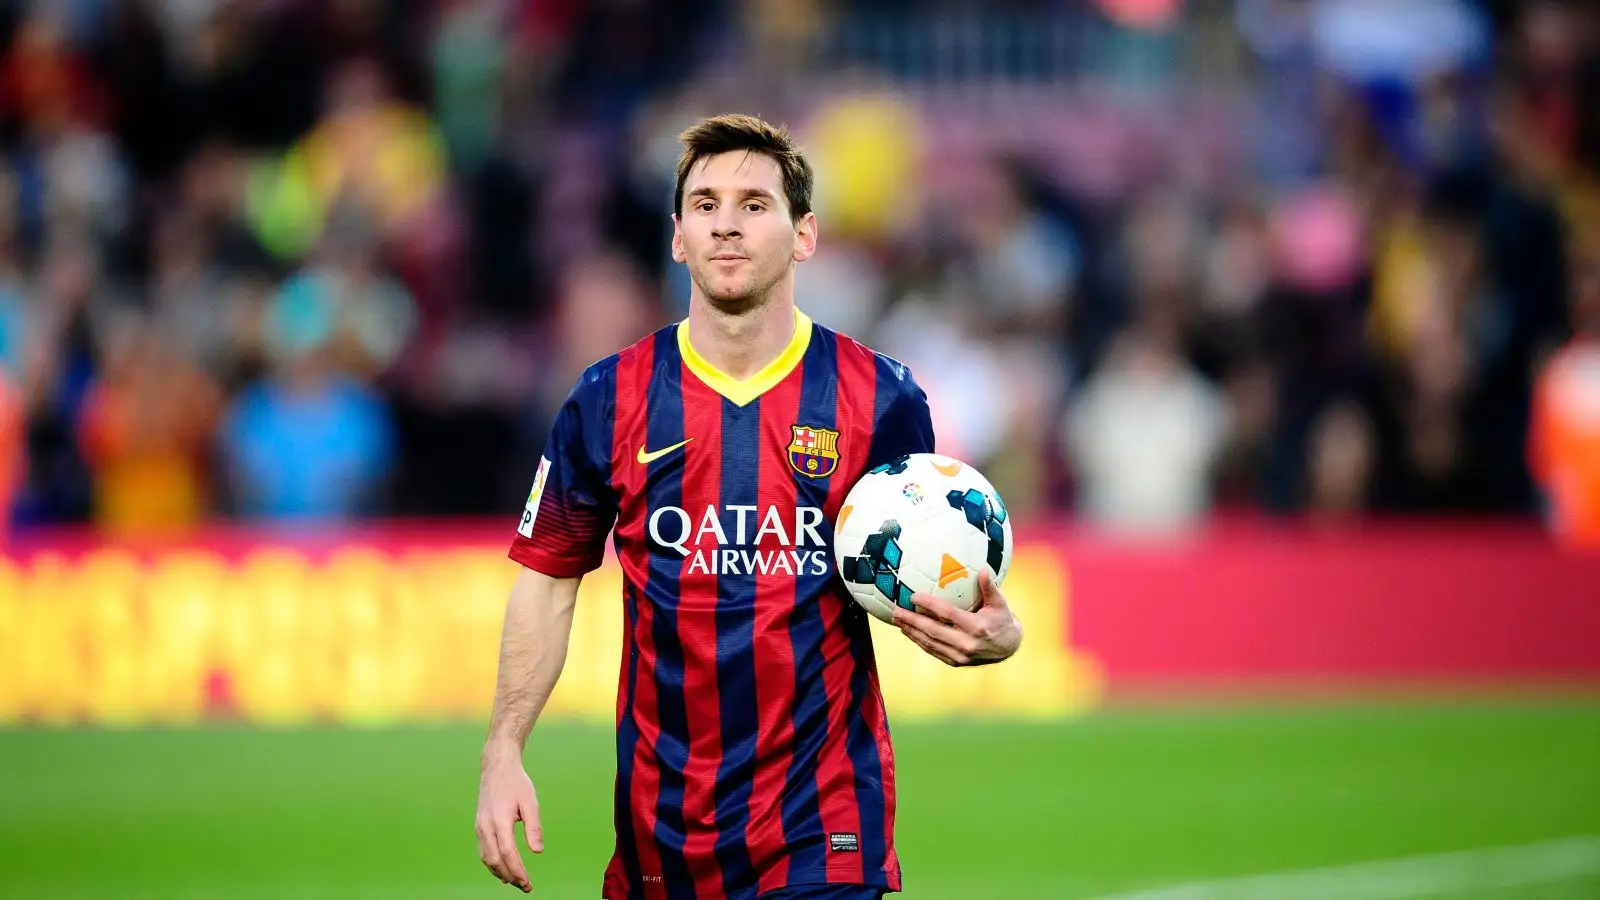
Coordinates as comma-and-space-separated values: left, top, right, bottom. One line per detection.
650, 504, 830, 577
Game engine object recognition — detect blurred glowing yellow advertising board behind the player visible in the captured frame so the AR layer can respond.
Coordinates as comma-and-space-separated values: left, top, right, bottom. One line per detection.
0, 527, 1099, 725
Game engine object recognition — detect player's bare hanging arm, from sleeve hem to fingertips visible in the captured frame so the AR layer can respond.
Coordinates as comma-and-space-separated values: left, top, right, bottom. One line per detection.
477, 569, 581, 892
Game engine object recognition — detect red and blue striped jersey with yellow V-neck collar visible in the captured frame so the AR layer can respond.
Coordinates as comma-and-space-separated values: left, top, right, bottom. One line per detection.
510, 304, 933, 900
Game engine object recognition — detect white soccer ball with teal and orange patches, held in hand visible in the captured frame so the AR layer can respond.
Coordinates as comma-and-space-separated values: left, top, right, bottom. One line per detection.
834, 453, 1011, 621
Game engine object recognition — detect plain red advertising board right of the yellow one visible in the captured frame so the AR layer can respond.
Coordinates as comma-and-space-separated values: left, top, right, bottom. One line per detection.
1050, 524, 1600, 689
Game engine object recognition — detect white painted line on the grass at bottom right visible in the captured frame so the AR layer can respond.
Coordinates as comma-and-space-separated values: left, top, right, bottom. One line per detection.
1093, 836, 1600, 900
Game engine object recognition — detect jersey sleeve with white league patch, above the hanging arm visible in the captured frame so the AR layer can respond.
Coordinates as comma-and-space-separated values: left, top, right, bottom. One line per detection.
507, 380, 616, 578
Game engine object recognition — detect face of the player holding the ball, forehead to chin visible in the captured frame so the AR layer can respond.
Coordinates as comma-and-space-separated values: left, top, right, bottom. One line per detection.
672, 151, 816, 314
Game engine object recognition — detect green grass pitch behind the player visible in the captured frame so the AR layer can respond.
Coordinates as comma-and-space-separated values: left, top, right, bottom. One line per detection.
0, 705, 1600, 900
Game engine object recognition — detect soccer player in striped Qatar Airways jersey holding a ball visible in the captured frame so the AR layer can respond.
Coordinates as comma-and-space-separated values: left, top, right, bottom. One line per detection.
477, 115, 1022, 900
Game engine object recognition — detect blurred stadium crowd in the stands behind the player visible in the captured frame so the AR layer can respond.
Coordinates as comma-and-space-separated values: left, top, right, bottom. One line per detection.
0, 0, 1600, 533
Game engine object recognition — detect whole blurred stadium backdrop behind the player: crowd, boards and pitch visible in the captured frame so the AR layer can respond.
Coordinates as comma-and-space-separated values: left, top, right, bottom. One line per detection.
0, 0, 1600, 900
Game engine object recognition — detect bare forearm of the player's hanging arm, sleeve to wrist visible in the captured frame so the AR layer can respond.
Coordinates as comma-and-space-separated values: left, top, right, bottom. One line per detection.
483, 570, 578, 762
